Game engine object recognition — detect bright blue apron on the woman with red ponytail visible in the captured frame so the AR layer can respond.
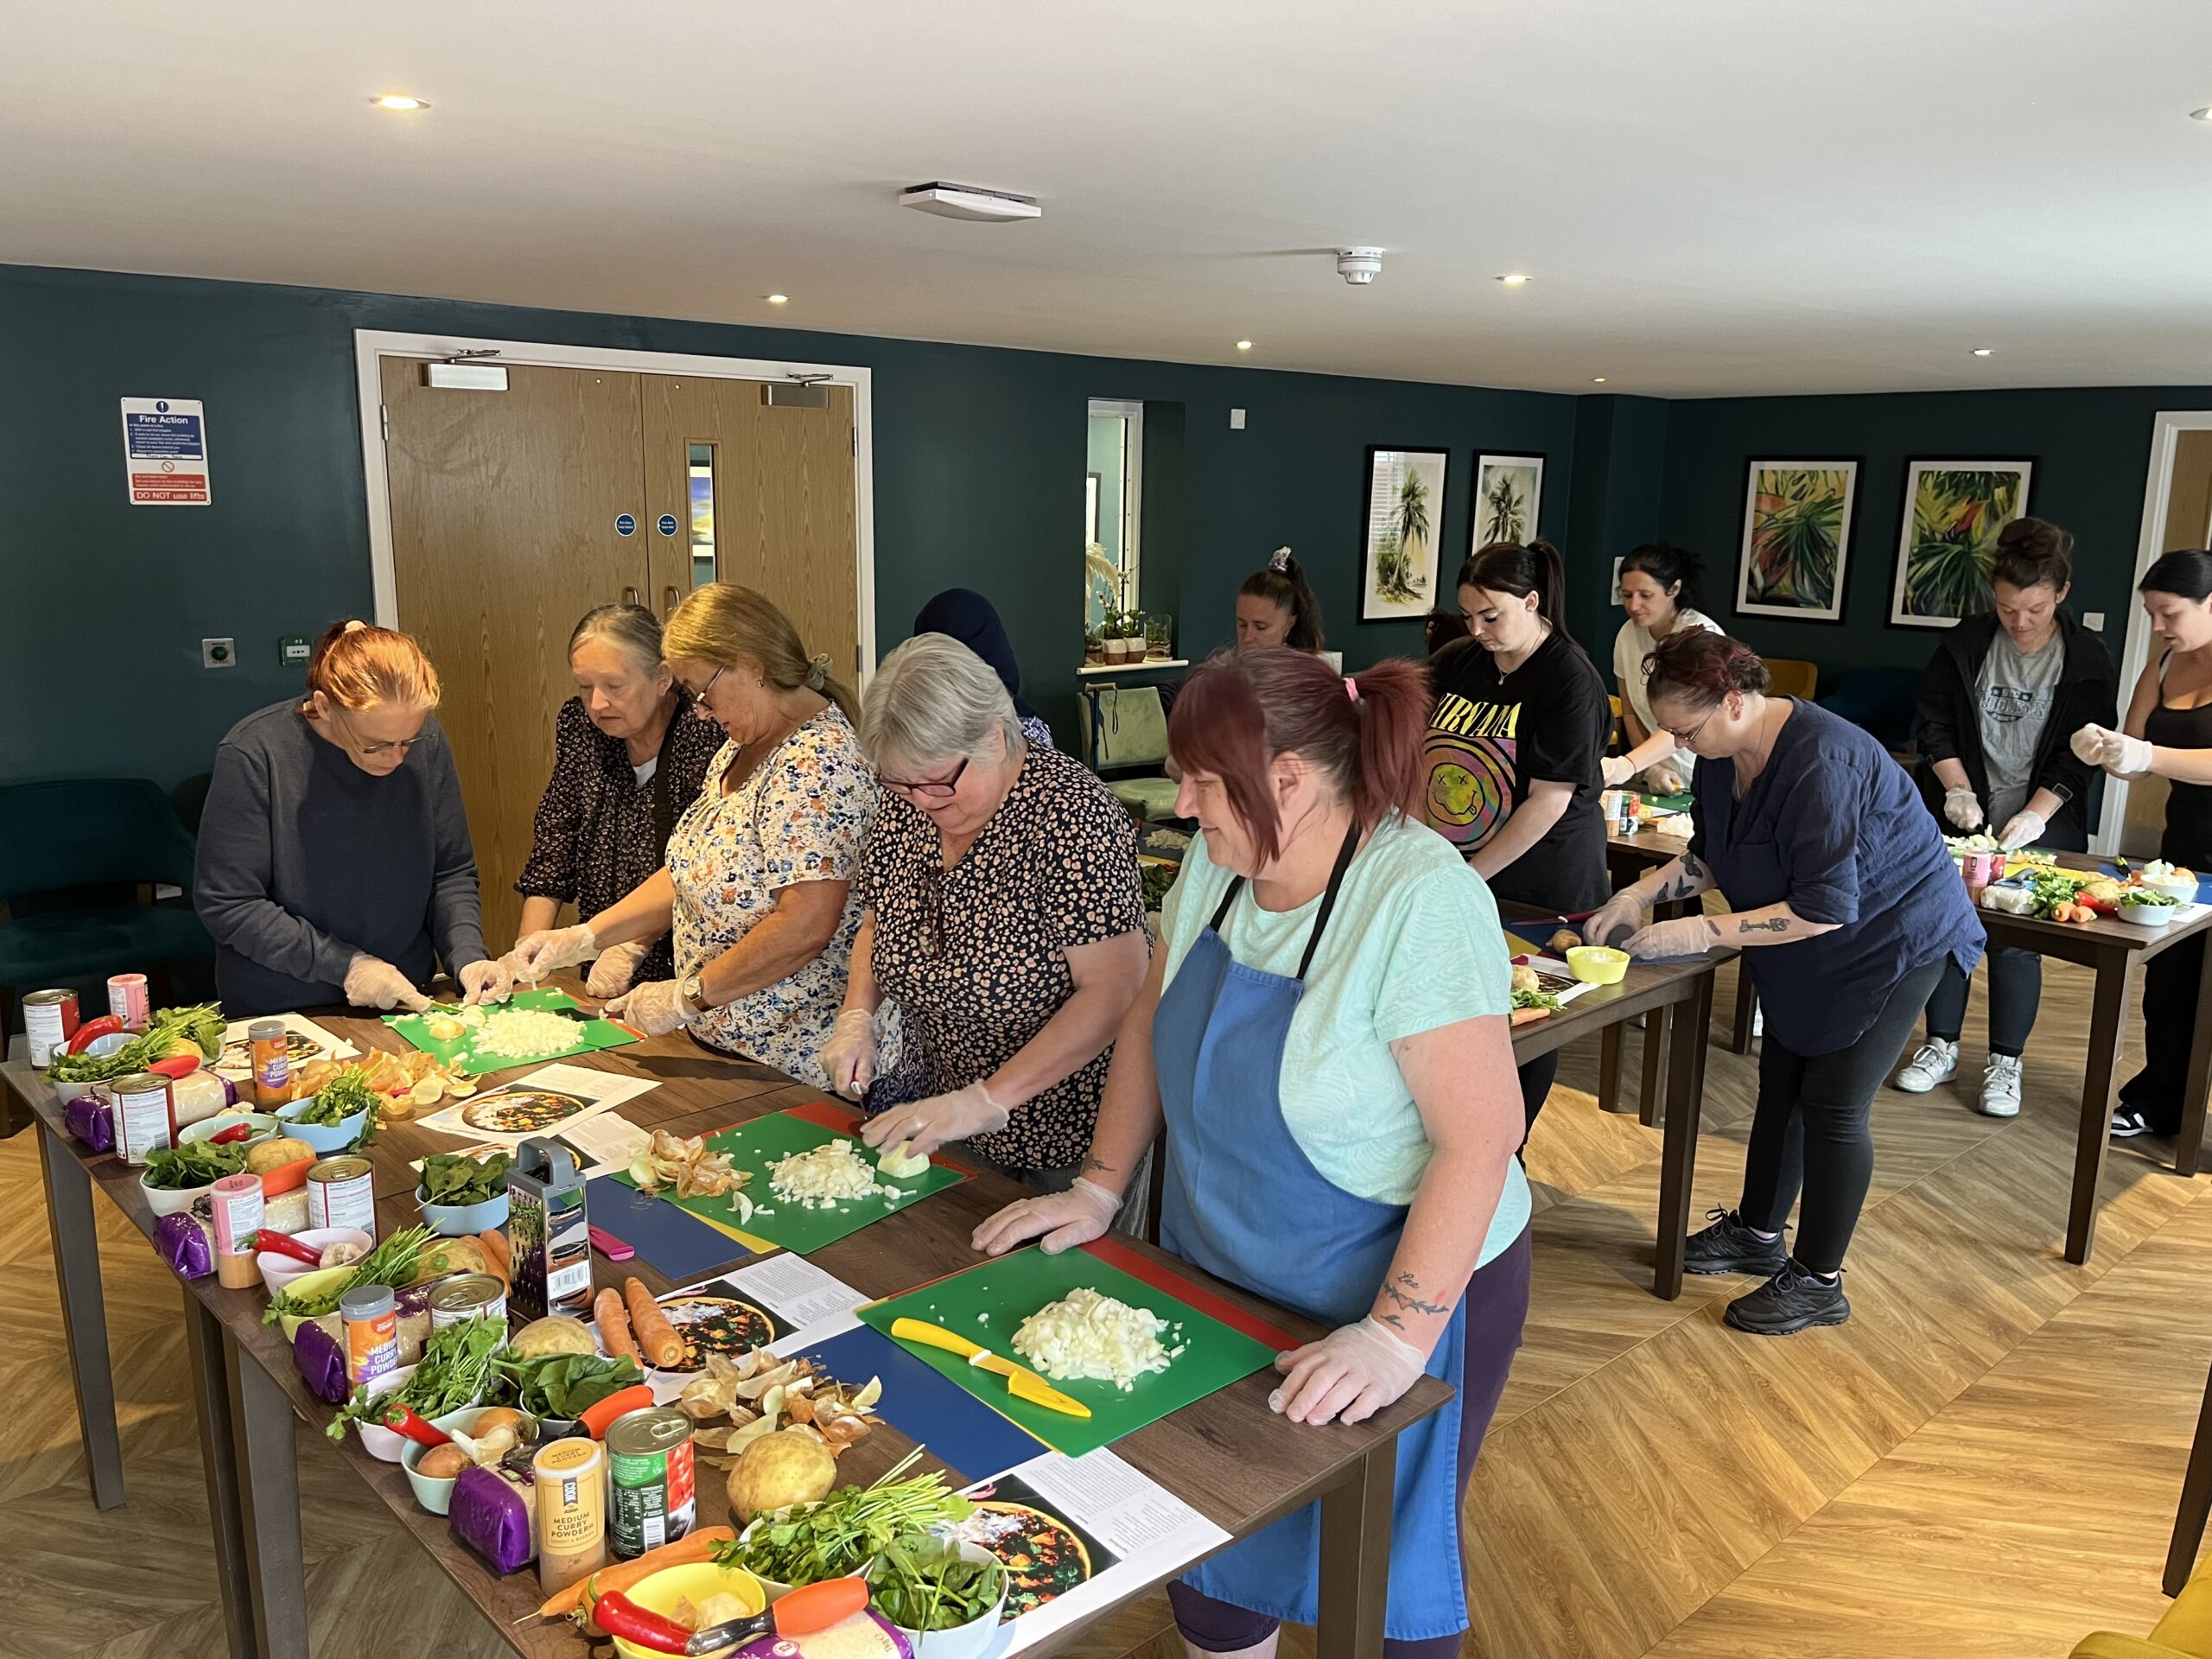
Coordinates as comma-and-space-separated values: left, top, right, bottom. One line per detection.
1153, 823, 1466, 1642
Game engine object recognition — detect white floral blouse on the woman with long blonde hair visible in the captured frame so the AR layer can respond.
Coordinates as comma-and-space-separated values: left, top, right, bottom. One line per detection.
668, 708, 878, 1089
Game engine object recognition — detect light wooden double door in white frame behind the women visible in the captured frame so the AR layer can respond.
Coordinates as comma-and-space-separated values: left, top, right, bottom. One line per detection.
383, 356, 861, 953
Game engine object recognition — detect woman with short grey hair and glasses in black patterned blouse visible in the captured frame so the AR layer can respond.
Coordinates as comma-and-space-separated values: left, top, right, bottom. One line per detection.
823, 632, 1150, 1192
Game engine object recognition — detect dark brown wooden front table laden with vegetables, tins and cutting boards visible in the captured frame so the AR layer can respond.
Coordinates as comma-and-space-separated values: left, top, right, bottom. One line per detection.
0, 978, 1459, 1659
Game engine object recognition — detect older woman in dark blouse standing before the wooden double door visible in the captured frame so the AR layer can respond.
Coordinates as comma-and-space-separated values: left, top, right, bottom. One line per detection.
515, 604, 721, 998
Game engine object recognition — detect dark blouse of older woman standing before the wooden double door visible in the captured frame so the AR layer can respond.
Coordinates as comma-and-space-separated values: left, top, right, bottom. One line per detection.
515, 696, 723, 984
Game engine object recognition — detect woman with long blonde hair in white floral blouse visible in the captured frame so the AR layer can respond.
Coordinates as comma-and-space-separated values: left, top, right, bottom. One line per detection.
513, 582, 876, 1089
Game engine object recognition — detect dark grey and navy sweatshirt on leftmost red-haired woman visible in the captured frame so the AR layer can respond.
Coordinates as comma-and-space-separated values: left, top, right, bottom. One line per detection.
193, 702, 486, 1020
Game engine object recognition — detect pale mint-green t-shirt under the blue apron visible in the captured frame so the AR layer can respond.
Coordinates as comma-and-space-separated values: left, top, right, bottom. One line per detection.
1161, 814, 1529, 1265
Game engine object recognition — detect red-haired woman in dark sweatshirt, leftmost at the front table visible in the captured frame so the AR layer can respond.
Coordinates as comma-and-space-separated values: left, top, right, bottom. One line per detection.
193, 621, 513, 1018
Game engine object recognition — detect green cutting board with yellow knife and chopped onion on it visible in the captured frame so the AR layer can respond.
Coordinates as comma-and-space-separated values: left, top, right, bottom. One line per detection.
858, 1249, 1276, 1458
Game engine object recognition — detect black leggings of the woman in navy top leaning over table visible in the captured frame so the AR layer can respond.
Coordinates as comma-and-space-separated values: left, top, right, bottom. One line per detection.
1741, 963, 1942, 1274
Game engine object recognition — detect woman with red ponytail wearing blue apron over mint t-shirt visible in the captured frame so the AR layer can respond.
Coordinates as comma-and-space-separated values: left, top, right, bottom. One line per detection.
976, 651, 1529, 1659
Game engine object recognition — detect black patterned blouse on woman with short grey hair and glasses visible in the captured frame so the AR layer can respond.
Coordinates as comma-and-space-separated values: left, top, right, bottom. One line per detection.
858, 747, 1144, 1170
